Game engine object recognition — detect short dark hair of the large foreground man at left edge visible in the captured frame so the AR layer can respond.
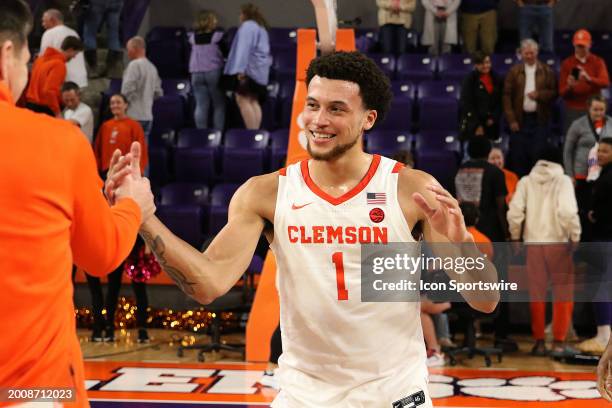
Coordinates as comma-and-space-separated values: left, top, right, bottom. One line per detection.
0, 0, 32, 52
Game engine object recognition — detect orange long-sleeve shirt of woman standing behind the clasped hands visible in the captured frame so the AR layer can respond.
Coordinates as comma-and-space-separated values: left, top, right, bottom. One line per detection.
94, 117, 149, 171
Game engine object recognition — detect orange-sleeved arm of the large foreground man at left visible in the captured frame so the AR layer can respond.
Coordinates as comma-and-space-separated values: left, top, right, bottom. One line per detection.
67, 129, 141, 276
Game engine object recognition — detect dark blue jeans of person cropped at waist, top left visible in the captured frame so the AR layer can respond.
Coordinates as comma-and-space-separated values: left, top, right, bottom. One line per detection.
83, 0, 123, 51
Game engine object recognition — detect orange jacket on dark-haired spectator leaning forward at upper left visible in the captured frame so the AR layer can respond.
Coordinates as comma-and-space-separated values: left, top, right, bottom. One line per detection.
26, 47, 66, 115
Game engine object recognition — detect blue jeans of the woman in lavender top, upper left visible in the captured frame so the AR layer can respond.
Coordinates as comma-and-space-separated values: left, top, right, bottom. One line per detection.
191, 68, 225, 130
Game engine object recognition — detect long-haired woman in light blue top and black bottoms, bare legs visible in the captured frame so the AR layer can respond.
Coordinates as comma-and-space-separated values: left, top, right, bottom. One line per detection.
224, 3, 272, 129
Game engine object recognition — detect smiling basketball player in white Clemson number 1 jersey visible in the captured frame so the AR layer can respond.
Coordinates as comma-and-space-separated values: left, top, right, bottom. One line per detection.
107, 52, 499, 408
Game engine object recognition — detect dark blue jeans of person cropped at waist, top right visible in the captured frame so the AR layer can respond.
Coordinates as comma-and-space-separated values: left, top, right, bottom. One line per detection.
519, 5, 554, 54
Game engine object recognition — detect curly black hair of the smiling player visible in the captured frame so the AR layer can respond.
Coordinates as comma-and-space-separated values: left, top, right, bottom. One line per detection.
306, 51, 393, 123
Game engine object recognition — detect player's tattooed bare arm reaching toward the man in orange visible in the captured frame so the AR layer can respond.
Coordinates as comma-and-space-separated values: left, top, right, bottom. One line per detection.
140, 179, 264, 304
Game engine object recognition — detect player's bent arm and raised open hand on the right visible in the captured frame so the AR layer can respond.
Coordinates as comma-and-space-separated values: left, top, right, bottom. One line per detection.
399, 170, 499, 313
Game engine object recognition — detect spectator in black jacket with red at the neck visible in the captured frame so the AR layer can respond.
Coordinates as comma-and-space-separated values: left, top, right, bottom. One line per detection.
460, 52, 502, 140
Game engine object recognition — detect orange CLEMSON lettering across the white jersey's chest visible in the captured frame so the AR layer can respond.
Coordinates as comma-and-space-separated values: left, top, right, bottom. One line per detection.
287, 225, 388, 244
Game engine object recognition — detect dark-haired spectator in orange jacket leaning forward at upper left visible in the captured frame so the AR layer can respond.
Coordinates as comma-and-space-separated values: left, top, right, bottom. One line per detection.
26, 37, 83, 118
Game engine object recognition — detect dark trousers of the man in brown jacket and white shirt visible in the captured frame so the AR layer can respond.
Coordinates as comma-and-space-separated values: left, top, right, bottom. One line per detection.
510, 113, 549, 177
